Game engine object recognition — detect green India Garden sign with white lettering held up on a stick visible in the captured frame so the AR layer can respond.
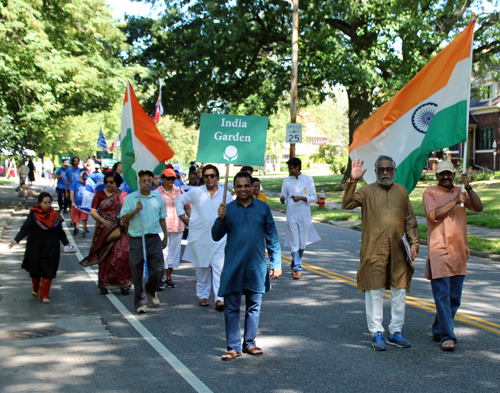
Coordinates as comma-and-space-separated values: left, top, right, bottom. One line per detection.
196, 113, 268, 166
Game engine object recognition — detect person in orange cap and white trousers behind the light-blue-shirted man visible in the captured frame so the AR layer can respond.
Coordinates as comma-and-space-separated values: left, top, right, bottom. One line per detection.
154, 168, 190, 291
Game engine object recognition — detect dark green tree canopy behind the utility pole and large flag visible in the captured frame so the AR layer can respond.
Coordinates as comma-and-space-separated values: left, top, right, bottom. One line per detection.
127, 0, 500, 175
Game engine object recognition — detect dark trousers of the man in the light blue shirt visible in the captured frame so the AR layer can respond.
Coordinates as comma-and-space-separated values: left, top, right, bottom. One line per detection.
129, 235, 163, 308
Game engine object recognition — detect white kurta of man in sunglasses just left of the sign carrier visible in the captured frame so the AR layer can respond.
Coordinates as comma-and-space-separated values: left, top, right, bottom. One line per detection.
174, 185, 233, 267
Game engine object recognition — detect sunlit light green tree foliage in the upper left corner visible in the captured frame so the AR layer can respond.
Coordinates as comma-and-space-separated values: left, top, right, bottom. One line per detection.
0, 0, 128, 150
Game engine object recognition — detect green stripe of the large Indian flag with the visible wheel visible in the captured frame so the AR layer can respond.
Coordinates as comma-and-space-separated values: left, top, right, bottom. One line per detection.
394, 101, 467, 193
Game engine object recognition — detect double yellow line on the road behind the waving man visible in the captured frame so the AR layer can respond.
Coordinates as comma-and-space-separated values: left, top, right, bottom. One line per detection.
281, 255, 500, 335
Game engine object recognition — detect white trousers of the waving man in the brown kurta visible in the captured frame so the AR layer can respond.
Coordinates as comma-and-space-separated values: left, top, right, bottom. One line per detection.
365, 286, 406, 334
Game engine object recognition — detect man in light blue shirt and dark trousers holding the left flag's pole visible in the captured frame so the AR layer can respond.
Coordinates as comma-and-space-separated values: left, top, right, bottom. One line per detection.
120, 170, 168, 314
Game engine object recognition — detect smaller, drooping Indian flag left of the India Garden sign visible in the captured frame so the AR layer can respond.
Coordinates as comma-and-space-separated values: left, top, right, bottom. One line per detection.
120, 82, 174, 191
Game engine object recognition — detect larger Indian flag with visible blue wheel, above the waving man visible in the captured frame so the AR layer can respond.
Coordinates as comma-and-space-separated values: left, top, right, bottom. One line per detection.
349, 22, 475, 193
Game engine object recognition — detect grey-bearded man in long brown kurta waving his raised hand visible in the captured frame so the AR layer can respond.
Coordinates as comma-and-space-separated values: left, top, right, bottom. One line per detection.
342, 156, 419, 351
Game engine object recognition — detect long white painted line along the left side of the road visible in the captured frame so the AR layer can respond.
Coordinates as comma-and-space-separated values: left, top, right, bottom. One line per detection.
64, 223, 213, 393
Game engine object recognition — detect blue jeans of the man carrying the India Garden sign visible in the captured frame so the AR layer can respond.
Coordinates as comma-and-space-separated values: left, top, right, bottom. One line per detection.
224, 289, 262, 353
